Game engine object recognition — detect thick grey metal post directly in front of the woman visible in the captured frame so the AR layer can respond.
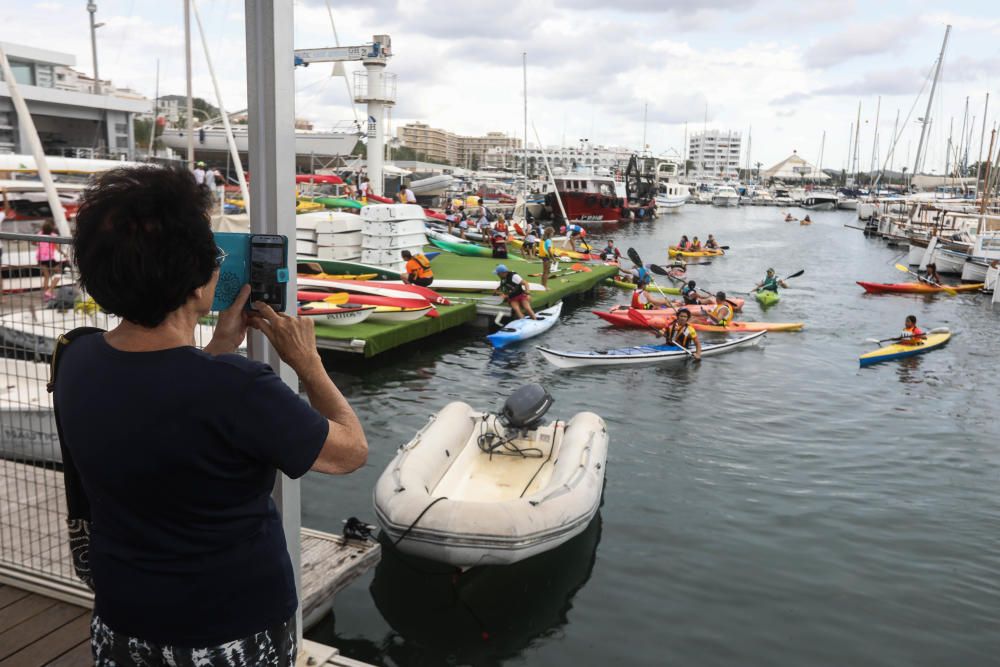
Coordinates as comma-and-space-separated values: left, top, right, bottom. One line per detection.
245, 0, 302, 643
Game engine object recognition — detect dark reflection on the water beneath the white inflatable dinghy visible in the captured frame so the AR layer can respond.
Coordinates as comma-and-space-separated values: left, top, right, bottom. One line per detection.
368, 512, 601, 665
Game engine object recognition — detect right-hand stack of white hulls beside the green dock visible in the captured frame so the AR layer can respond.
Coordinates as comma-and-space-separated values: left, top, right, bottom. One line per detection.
361, 204, 427, 272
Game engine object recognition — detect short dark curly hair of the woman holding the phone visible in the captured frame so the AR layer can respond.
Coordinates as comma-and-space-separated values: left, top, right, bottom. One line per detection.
73, 165, 218, 327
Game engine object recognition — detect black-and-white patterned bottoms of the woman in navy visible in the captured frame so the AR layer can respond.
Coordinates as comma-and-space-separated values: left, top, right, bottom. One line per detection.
90, 614, 297, 667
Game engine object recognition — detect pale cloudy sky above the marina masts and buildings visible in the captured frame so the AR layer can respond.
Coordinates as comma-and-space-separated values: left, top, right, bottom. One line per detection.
0, 0, 1000, 173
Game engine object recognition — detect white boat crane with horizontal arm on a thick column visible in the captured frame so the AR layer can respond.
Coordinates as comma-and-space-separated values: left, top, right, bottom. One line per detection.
295, 35, 396, 195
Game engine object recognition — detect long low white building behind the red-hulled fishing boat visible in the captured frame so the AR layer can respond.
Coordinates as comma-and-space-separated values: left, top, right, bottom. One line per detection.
485, 141, 635, 175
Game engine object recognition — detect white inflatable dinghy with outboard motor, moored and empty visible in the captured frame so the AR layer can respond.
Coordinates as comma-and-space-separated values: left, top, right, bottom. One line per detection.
374, 401, 608, 568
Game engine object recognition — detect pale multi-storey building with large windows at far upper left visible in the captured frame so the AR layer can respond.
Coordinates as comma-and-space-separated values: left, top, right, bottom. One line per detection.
0, 42, 153, 159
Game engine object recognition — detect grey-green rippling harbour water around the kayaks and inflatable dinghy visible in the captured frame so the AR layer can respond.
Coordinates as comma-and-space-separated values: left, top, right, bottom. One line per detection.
302, 205, 1000, 667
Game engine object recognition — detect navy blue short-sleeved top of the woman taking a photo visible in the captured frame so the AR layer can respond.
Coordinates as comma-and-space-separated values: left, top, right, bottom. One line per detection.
55, 334, 329, 647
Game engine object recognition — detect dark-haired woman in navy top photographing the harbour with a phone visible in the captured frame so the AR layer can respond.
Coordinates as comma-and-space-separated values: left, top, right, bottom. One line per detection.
52, 165, 368, 667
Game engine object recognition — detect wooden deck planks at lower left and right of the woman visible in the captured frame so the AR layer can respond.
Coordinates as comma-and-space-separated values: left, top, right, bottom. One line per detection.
0, 460, 381, 667
